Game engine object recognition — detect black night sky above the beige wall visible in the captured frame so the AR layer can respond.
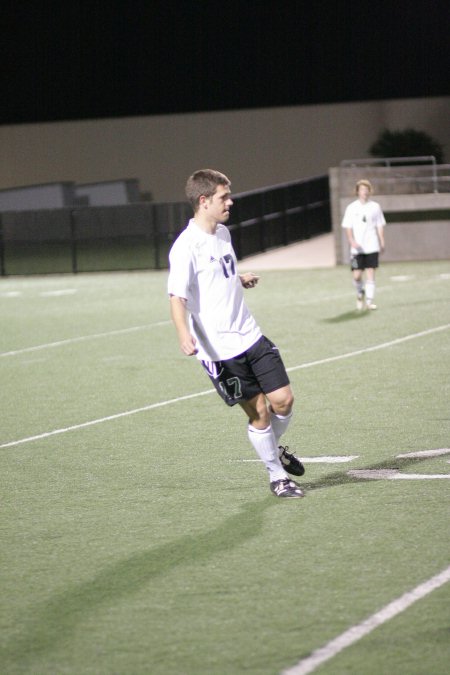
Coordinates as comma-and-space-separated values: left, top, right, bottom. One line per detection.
0, 0, 450, 124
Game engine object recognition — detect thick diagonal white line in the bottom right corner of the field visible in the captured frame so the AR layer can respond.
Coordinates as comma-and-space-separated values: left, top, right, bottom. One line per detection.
282, 567, 450, 675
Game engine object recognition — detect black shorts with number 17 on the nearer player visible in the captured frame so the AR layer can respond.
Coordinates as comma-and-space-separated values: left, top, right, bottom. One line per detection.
202, 335, 289, 406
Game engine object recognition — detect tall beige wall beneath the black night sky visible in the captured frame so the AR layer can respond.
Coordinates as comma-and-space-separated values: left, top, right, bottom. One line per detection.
0, 97, 450, 201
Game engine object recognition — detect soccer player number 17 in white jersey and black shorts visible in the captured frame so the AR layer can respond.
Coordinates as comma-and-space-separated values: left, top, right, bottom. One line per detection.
168, 169, 305, 498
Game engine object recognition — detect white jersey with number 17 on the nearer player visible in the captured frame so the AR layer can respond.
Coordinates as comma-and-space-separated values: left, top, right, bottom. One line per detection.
168, 218, 261, 361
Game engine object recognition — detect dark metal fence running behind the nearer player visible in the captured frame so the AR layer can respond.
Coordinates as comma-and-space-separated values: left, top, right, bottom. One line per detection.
0, 175, 331, 276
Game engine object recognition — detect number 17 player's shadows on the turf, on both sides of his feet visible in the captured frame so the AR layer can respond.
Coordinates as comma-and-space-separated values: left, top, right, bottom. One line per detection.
1, 458, 442, 672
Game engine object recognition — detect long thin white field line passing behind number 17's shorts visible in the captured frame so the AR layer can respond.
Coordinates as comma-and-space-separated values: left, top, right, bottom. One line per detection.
0, 324, 450, 449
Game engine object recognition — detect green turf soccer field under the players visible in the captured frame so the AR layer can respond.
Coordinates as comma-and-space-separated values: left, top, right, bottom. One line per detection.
0, 261, 450, 675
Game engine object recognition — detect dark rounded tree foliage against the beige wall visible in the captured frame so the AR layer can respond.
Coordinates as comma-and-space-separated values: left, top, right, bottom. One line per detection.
369, 128, 444, 164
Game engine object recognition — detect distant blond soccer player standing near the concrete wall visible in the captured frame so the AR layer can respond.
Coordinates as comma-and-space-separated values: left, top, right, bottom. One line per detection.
342, 180, 386, 310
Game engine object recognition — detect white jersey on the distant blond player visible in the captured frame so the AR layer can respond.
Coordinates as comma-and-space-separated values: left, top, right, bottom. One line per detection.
342, 199, 386, 254
